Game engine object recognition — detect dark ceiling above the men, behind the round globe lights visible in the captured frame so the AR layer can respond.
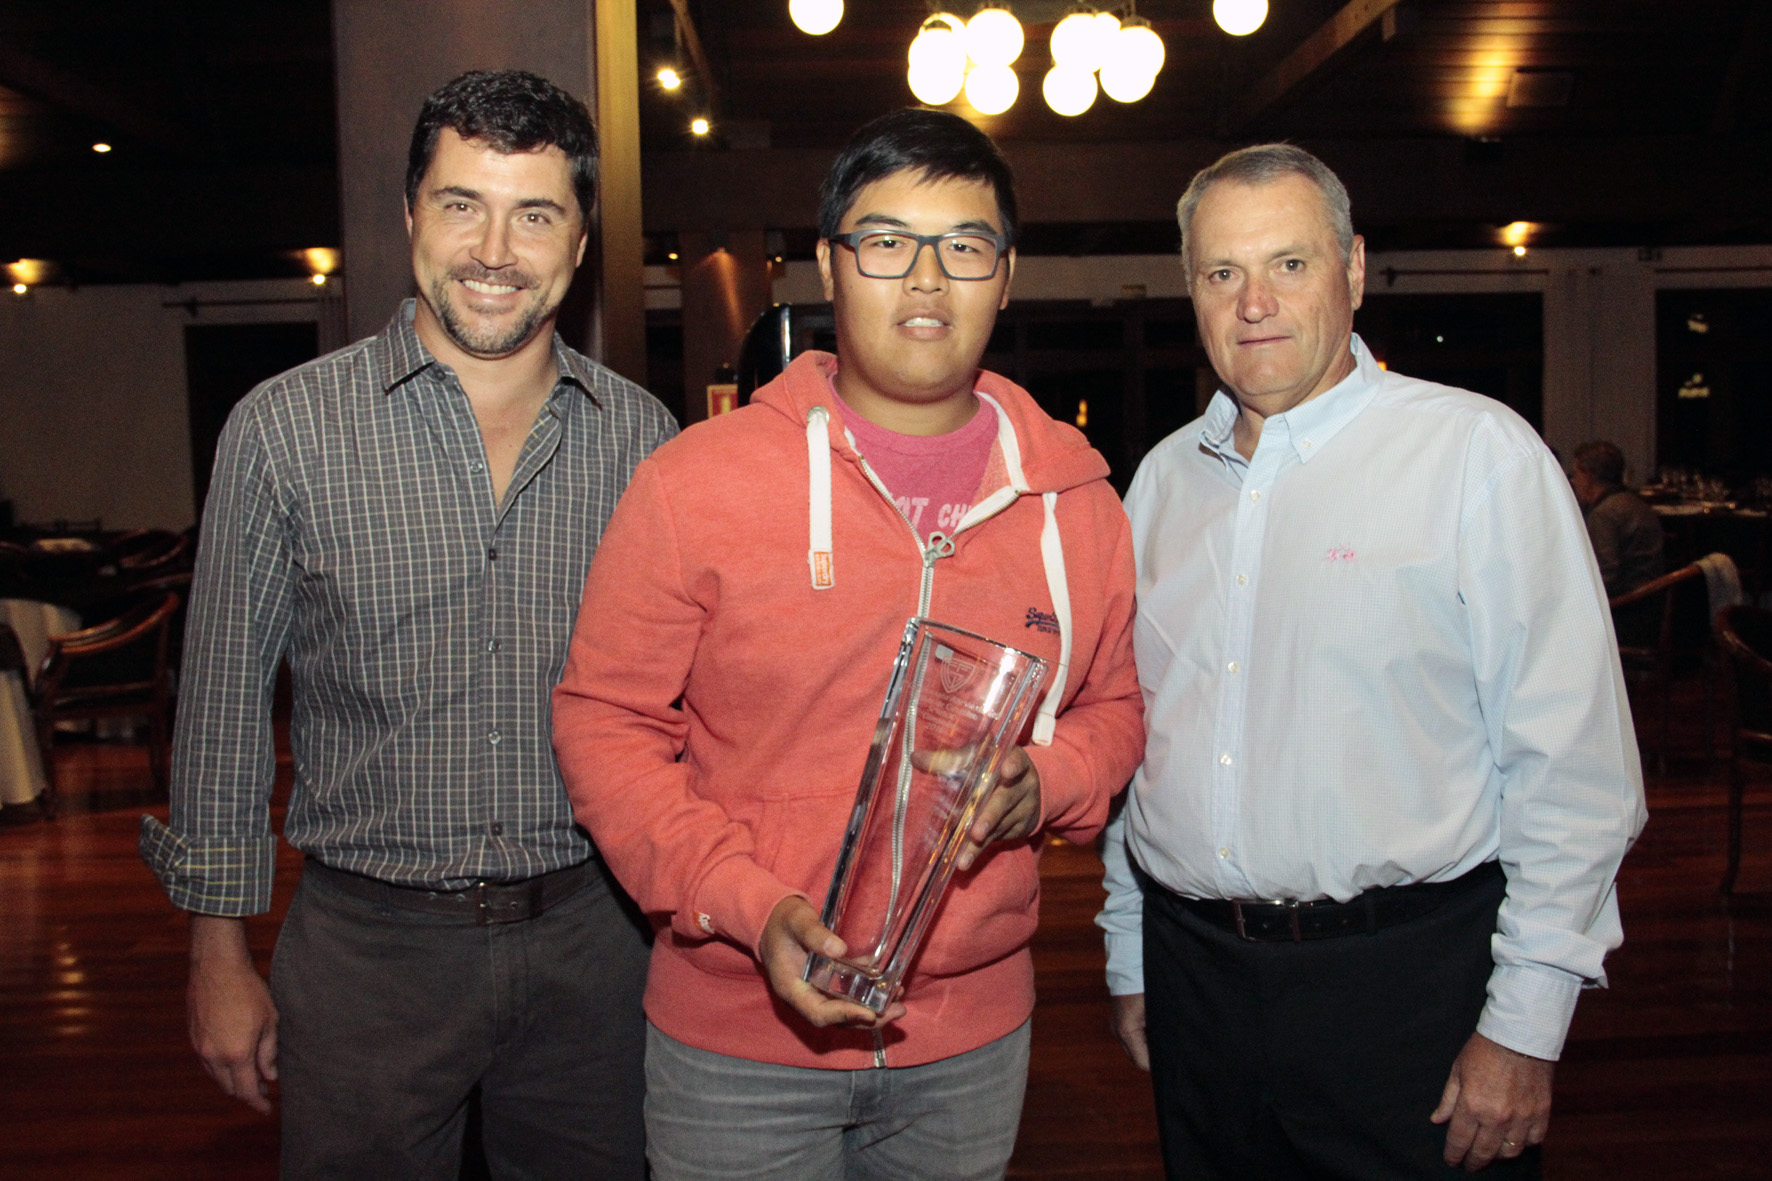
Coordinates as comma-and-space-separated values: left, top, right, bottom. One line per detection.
0, 0, 1772, 282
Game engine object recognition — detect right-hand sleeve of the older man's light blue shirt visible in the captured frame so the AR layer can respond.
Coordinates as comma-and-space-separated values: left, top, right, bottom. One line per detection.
1458, 434, 1646, 1059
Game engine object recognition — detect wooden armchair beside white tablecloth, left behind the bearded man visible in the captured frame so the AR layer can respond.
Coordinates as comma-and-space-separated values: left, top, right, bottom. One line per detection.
32, 594, 179, 817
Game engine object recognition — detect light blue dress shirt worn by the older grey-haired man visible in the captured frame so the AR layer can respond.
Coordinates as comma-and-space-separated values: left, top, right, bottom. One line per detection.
1099, 337, 1644, 1059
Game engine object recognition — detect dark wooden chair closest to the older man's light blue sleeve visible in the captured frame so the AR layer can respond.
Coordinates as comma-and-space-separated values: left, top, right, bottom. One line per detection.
1609, 562, 1715, 775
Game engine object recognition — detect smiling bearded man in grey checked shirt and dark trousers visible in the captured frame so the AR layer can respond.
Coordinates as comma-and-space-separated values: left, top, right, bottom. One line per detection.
142, 71, 675, 1177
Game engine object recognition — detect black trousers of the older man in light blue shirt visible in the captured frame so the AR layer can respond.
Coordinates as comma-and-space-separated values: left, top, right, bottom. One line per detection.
1145, 871, 1538, 1181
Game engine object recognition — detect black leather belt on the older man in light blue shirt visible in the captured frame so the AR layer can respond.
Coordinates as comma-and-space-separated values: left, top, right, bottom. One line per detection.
1157, 862, 1503, 943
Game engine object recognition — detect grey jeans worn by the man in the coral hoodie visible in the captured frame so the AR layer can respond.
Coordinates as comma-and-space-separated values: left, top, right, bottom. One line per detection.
647, 1023, 1031, 1181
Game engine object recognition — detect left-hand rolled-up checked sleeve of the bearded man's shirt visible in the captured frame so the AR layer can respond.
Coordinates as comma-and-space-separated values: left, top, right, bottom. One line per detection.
140, 395, 294, 915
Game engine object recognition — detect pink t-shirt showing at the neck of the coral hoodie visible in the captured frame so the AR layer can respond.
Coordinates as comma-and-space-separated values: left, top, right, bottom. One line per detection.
836, 397, 998, 539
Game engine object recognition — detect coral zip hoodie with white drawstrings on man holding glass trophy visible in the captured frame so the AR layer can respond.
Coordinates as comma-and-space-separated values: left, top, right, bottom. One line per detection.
553, 353, 1143, 1069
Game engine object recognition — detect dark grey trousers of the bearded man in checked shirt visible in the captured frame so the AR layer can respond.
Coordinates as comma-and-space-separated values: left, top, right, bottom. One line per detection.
271, 864, 647, 1181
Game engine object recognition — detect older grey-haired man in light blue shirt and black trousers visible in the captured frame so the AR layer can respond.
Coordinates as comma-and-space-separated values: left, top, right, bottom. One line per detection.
1100, 144, 1644, 1181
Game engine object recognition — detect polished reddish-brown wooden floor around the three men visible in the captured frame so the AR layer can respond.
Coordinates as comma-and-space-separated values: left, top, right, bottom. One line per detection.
0, 702, 1772, 1181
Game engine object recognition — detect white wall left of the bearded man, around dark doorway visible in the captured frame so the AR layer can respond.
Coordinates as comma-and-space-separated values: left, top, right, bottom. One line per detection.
0, 278, 344, 528
